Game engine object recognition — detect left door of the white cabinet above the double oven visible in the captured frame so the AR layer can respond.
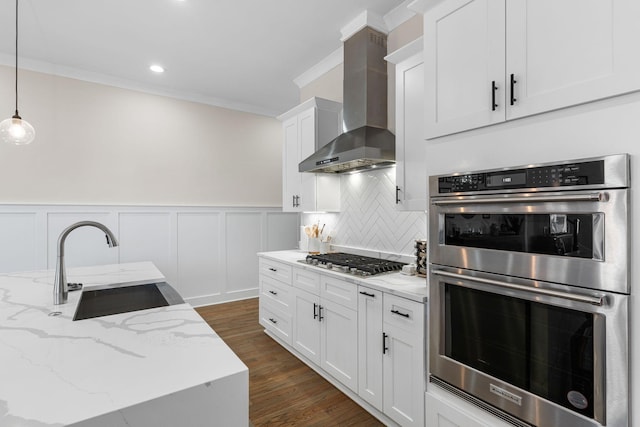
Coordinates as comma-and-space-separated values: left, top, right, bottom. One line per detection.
424, 0, 506, 138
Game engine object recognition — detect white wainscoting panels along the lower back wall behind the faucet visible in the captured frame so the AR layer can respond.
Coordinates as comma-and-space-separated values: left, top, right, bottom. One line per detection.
0, 205, 300, 305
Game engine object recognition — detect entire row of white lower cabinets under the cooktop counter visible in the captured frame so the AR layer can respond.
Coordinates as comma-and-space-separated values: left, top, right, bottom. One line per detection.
260, 261, 428, 427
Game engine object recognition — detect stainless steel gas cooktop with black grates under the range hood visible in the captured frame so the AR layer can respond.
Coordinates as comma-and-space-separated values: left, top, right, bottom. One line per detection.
300, 252, 405, 276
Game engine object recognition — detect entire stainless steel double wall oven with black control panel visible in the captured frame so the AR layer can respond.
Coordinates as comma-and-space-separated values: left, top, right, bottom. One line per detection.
429, 154, 630, 427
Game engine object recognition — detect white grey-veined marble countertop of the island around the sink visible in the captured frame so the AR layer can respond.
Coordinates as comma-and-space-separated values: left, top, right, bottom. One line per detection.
0, 262, 248, 427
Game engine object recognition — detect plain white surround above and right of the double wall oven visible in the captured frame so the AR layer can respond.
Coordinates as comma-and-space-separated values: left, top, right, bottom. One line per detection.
426, 93, 640, 425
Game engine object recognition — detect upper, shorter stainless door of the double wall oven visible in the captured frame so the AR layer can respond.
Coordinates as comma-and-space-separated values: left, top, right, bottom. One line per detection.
429, 189, 629, 293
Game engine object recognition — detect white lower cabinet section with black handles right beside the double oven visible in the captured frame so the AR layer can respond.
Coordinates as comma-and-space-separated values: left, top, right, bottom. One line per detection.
358, 286, 425, 426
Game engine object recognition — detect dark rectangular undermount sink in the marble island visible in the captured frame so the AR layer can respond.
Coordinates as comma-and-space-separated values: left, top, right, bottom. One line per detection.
73, 282, 184, 320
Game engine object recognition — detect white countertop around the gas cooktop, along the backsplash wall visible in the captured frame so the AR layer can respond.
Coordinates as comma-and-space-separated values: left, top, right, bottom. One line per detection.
258, 250, 428, 302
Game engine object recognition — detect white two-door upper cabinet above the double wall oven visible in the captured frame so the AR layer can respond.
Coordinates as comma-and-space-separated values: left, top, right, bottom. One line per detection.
424, 0, 640, 138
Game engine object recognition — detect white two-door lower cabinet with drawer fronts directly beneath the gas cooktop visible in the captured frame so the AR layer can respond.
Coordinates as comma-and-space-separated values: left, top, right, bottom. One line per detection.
293, 271, 358, 391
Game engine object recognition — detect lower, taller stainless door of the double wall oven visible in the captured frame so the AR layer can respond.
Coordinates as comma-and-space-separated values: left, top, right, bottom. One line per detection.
429, 265, 629, 427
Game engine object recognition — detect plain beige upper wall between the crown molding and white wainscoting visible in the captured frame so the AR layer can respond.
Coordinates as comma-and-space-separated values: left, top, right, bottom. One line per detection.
0, 66, 282, 206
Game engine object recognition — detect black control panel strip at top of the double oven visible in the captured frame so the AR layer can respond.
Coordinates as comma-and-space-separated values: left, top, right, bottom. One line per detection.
438, 160, 605, 194
